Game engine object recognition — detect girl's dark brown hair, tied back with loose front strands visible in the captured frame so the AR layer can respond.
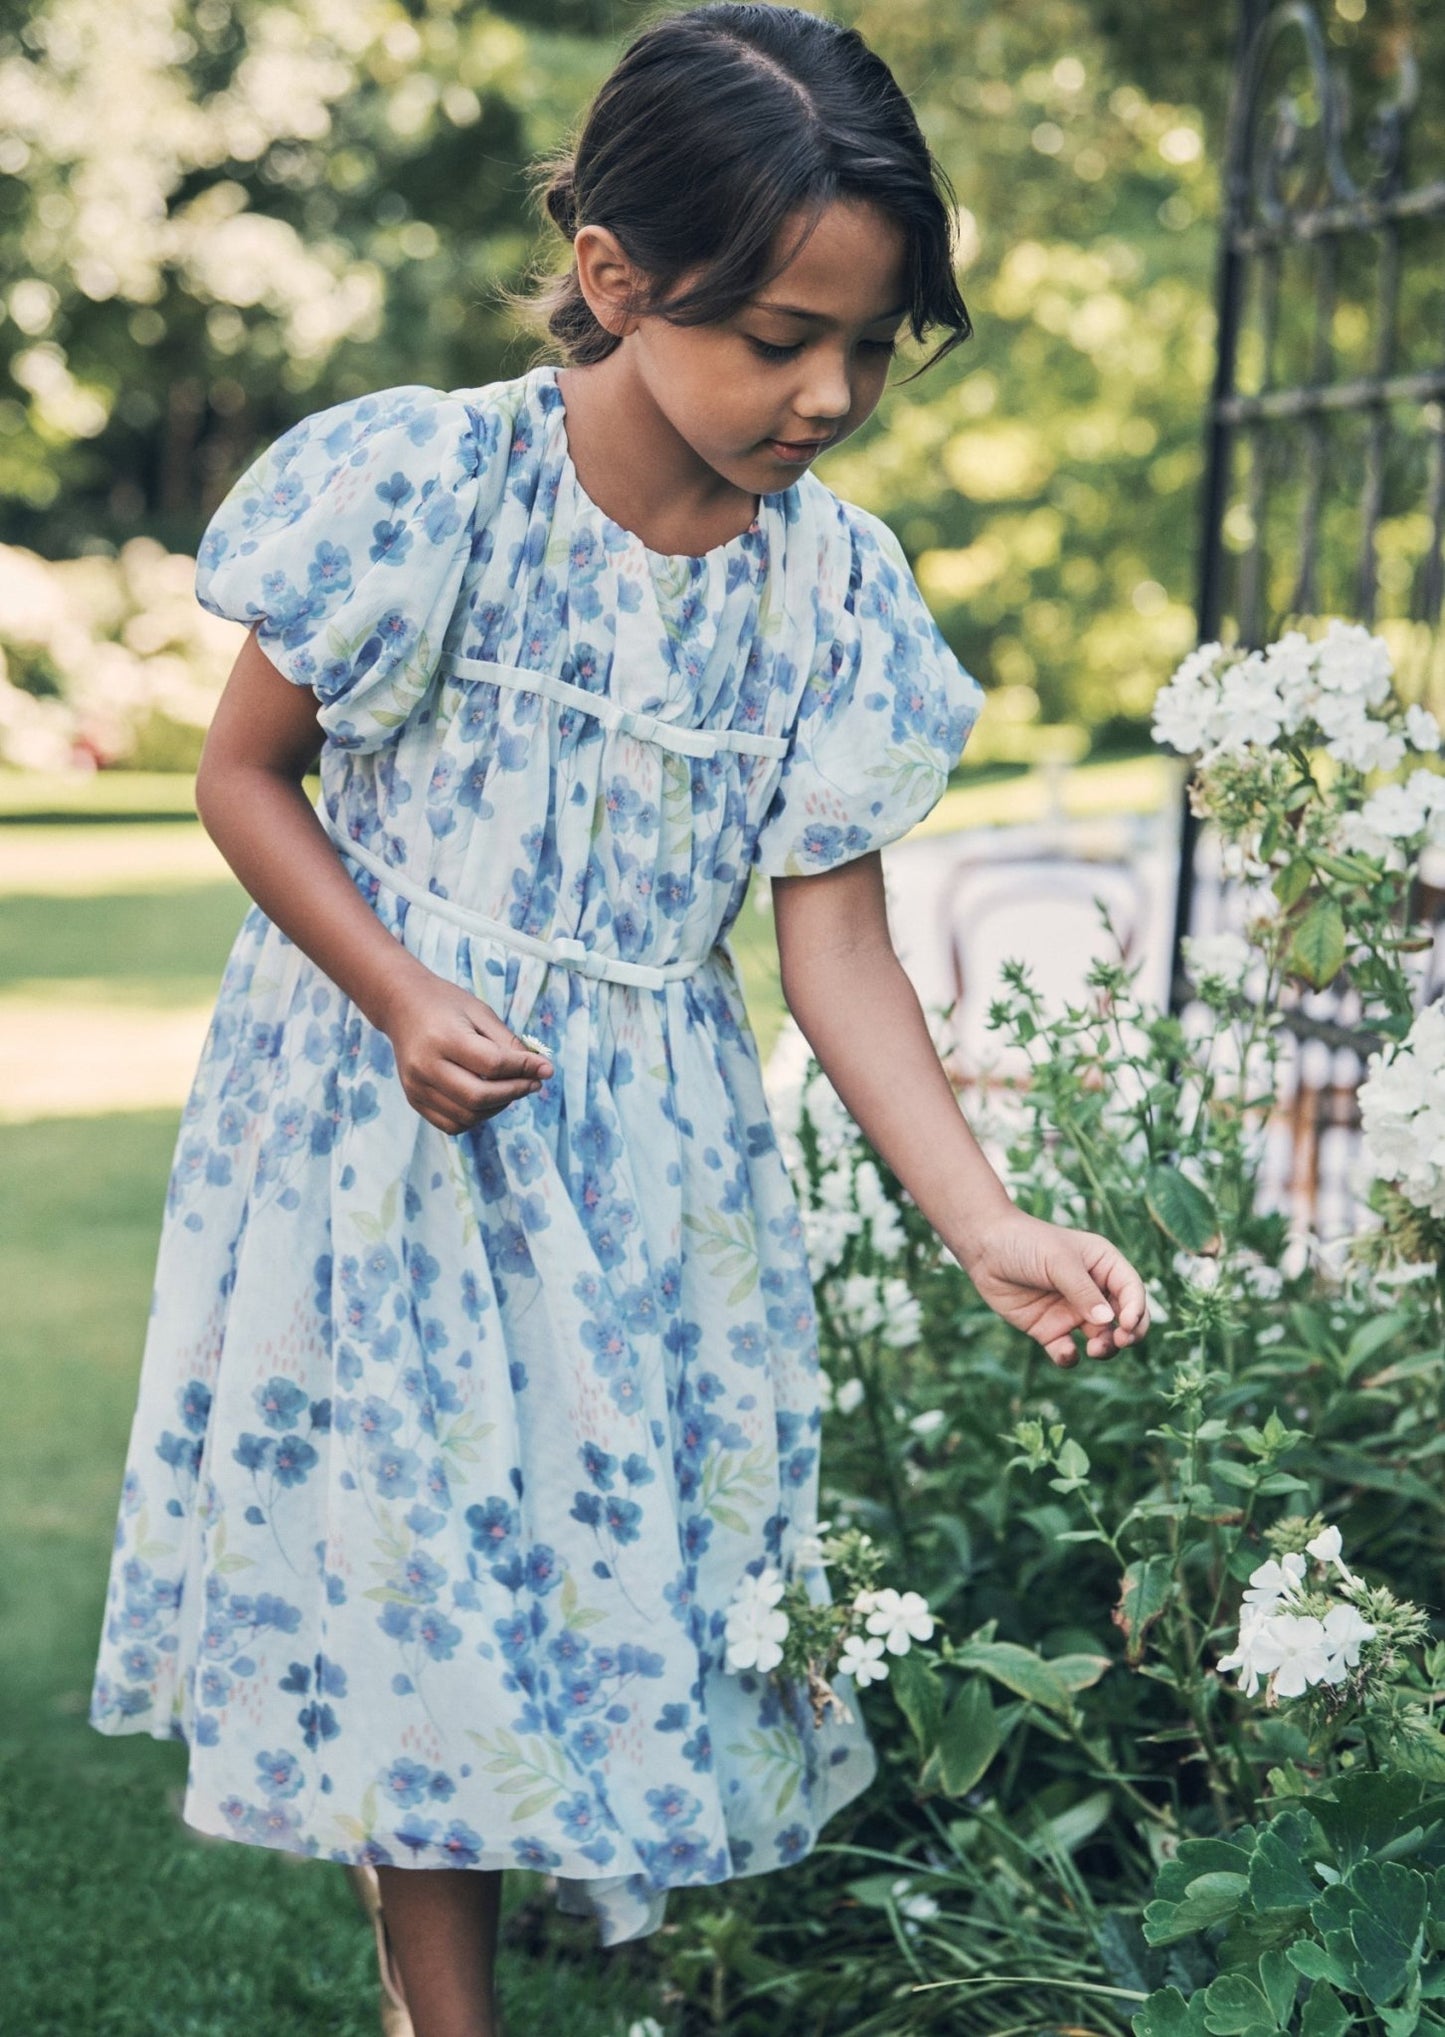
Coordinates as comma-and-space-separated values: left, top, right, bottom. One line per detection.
507, 0, 972, 373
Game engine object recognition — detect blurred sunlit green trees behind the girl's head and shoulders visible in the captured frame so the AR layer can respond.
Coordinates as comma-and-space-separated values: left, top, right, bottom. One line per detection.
0, 0, 1434, 733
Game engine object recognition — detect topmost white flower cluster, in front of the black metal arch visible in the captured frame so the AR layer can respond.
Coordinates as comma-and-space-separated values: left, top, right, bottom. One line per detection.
1154, 619, 1441, 776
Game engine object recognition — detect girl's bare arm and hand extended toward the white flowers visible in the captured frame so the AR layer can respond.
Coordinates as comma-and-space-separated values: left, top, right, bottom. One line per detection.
772, 849, 1149, 1365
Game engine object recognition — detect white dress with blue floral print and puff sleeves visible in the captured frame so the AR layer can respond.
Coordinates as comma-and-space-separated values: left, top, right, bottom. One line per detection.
90, 367, 980, 1943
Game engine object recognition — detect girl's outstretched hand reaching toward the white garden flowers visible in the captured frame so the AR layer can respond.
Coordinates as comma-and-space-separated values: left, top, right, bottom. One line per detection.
964, 1208, 1149, 1367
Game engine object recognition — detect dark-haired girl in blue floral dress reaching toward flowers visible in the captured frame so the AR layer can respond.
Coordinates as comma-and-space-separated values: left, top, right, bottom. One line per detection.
90, 6, 1147, 2037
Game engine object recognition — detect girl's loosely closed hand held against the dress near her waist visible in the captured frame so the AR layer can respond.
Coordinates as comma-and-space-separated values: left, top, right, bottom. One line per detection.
383, 970, 552, 1133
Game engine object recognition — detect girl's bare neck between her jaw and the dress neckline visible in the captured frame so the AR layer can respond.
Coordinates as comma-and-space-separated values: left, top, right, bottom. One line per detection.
556, 348, 760, 556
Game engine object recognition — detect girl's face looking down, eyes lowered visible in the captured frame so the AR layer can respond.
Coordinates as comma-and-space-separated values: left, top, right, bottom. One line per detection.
583, 200, 907, 495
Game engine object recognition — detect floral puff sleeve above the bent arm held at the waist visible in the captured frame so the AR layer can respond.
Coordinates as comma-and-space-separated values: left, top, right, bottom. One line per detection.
196, 387, 493, 750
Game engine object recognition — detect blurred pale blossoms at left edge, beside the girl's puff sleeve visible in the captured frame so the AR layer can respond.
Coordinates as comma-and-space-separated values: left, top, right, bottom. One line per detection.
0, 538, 245, 772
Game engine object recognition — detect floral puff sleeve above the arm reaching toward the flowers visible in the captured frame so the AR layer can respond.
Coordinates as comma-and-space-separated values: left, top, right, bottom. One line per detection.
752, 499, 982, 876
